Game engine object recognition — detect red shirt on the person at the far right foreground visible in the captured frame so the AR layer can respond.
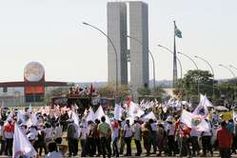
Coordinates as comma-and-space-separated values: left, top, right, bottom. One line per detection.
217, 128, 232, 148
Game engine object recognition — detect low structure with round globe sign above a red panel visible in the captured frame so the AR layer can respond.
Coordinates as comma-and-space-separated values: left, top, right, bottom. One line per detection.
0, 62, 68, 106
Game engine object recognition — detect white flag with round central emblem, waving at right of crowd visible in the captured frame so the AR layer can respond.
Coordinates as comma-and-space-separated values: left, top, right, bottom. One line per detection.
180, 110, 210, 131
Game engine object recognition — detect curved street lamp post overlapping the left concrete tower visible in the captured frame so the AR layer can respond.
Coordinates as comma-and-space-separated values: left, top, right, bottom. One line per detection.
82, 22, 118, 93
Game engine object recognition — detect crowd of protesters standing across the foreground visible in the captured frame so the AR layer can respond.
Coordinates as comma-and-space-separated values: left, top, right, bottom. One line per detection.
0, 95, 237, 158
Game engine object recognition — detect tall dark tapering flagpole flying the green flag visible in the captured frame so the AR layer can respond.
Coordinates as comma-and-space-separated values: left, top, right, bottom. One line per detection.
173, 21, 177, 88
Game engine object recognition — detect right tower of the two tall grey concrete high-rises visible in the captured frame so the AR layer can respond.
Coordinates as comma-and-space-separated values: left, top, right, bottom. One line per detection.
129, 1, 149, 90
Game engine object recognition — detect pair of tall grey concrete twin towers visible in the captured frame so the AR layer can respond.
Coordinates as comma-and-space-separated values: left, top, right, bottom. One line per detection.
107, 1, 149, 90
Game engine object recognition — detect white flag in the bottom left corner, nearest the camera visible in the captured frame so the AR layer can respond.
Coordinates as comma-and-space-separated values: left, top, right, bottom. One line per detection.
13, 124, 37, 158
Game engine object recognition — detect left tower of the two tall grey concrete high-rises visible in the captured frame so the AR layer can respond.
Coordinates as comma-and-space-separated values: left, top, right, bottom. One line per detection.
107, 2, 128, 85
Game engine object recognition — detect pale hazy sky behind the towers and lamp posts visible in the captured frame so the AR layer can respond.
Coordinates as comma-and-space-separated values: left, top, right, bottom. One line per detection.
0, 0, 237, 82
